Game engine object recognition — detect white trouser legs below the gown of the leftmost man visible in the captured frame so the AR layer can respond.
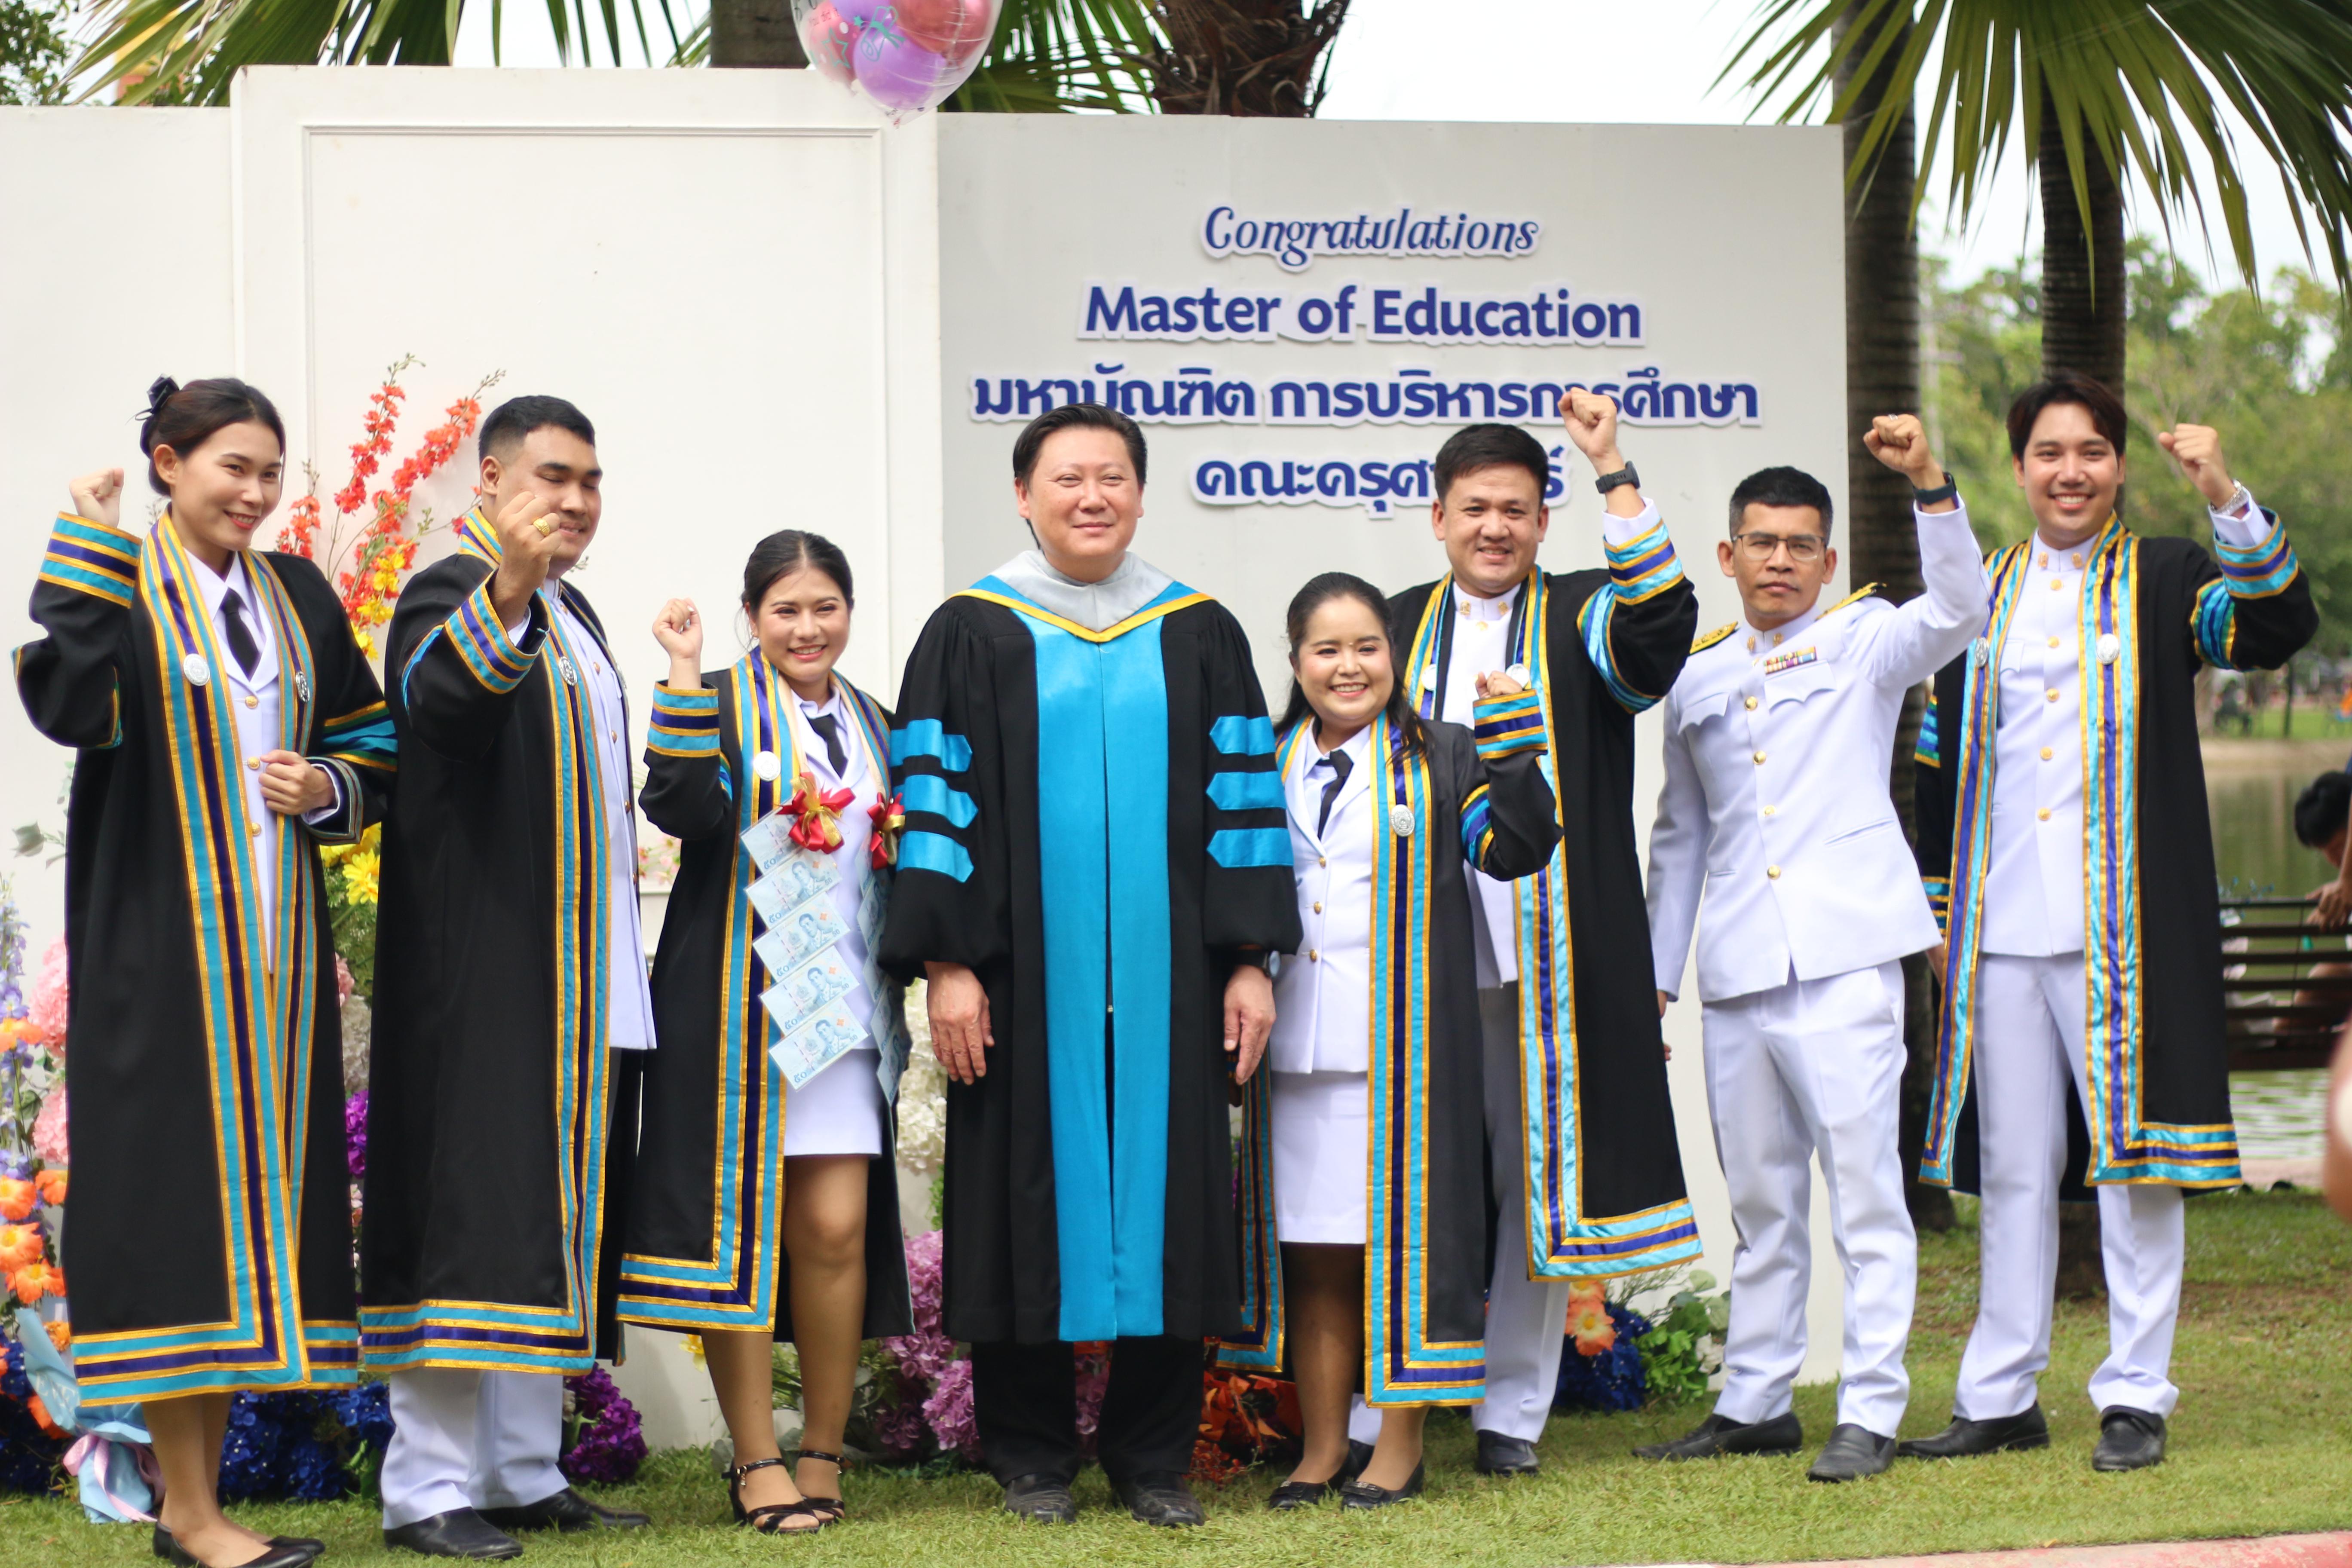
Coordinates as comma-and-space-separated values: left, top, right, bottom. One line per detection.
383, 1366, 569, 1530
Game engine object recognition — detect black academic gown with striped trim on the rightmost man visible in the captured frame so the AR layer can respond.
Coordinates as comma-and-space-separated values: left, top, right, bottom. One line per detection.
1914, 520, 2319, 1197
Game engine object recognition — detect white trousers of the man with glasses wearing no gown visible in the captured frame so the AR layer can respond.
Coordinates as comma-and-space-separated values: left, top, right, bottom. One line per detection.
1700, 964, 1919, 1436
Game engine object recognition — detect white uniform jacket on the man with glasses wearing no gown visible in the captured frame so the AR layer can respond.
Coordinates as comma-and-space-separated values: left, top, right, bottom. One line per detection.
1649, 510, 1992, 1001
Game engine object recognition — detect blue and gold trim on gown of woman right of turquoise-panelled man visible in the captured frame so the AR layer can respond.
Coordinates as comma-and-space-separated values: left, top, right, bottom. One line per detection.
1218, 715, 1491, 1406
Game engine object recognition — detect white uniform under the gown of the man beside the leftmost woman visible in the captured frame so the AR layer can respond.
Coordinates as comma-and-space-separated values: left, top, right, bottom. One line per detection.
381, 583, 654, 1530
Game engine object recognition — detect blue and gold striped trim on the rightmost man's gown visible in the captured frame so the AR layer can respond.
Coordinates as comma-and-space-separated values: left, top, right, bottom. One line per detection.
1919, 517, 2239, 1187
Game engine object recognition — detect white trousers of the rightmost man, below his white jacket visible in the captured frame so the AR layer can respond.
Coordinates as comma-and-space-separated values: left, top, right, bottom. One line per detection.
1952, 952, 2187, 1420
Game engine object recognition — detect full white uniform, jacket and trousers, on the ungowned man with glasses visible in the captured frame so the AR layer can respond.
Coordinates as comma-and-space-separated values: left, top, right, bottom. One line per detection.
1649, 510, 1992, 1439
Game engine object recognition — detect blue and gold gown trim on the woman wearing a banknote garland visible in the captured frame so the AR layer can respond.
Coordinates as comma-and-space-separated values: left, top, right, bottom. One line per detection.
621, 649, 889, 1331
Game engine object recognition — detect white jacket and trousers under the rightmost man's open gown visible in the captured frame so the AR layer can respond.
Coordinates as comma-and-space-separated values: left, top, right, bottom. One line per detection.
1952, 487, 2272, 1420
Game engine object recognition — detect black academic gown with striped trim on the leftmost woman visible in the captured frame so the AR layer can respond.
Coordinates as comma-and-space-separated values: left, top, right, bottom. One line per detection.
16, 515, 393, 1403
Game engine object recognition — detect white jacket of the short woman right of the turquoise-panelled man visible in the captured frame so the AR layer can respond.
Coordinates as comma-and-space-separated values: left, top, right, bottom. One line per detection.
1265, 720, 1387, 1072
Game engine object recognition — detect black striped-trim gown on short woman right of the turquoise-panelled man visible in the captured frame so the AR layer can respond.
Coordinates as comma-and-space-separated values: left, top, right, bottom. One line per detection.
1218, 693, 1559, 1406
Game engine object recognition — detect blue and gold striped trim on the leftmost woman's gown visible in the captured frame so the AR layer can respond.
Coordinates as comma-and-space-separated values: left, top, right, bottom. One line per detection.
73, 512, 358, 1401
